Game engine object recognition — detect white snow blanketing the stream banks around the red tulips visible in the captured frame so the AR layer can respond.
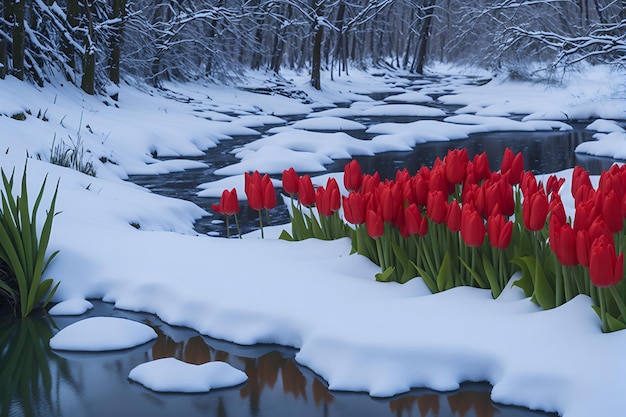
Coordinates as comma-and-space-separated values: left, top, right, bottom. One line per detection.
0, 63, 626, 417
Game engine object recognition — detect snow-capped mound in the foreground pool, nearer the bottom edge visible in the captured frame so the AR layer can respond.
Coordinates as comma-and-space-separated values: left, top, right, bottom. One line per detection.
128, 358, 248, 393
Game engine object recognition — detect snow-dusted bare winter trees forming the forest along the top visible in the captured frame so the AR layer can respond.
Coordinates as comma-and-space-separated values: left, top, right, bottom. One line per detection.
0, 0, 626, 94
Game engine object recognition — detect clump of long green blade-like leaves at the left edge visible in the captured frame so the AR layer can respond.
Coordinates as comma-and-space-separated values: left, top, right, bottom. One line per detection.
0, 164, 59, 318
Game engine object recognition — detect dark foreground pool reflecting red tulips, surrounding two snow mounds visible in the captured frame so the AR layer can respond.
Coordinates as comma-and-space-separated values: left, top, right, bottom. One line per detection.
0, 302, 547, 417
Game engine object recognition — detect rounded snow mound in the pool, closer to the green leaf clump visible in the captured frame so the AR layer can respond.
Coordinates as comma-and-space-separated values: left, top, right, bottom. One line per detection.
50, 317, 157, 352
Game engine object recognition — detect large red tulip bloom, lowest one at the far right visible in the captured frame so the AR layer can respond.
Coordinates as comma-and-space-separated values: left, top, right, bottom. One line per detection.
589, 236, 624, 287
